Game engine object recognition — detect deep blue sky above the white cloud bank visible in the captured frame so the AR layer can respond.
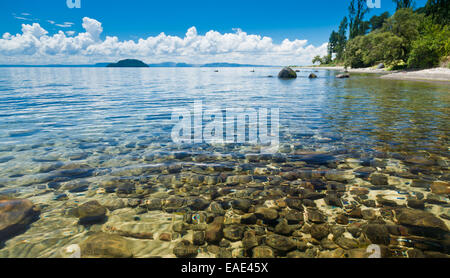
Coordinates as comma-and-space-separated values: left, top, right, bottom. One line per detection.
0, 0, 426, 62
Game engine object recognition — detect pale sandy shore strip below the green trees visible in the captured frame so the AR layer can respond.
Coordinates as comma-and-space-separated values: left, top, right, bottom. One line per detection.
298, 66, 450, 82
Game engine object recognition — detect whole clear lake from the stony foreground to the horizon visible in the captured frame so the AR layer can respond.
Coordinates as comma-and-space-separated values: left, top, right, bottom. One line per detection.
0, 68, 450, 257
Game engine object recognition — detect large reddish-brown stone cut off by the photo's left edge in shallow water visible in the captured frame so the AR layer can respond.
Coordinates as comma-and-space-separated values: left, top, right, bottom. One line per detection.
0, 199, 40, 242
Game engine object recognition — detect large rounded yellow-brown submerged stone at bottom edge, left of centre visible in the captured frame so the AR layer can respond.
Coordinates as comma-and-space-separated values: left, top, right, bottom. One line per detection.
80, 233, 133, 258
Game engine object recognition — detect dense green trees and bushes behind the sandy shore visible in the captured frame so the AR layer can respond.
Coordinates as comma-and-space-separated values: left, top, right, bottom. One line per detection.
313, 0, 450, 69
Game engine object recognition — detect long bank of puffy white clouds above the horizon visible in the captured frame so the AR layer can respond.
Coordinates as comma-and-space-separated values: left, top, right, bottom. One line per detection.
0, 17, 327, 65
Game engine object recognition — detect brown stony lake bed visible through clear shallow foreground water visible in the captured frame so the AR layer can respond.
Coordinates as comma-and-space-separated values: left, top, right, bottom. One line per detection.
0, 146, 450, 258
